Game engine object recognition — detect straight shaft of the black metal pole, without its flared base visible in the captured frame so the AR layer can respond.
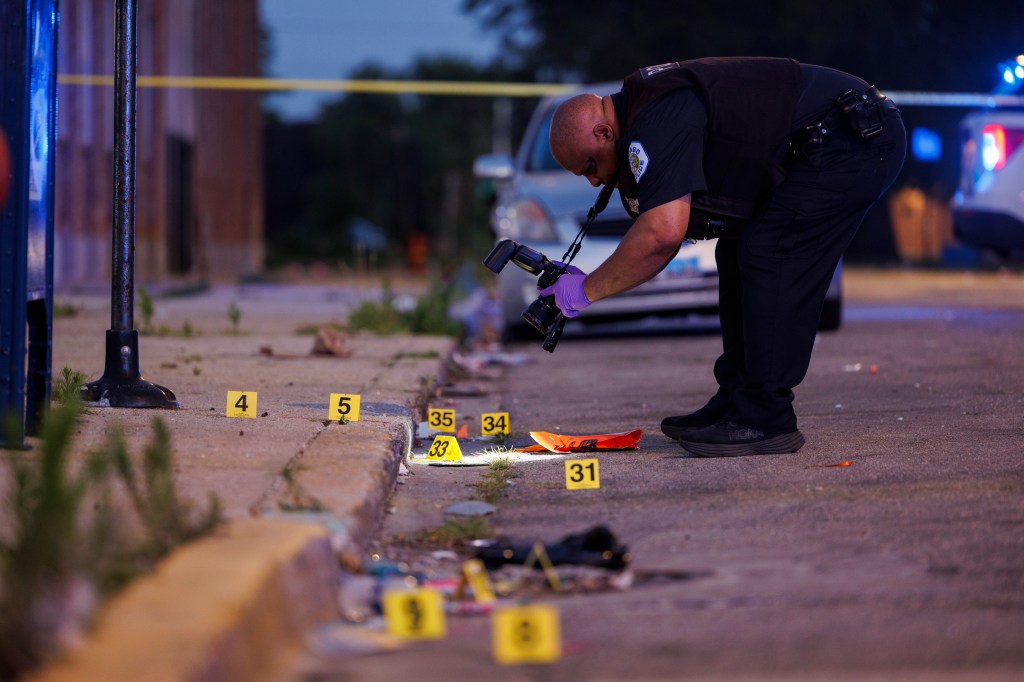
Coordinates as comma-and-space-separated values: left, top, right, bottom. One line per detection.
111, 0, 138, 332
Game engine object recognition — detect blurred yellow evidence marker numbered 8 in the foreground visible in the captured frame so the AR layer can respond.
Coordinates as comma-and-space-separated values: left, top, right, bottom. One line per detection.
490, 604, 562, 666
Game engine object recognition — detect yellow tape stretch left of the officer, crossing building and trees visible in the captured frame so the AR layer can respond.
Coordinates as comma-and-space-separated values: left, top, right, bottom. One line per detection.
57, 74, 580, 97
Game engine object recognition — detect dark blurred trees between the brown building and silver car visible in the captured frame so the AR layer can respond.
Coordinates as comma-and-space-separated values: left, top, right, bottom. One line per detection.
265, 56, 532, 268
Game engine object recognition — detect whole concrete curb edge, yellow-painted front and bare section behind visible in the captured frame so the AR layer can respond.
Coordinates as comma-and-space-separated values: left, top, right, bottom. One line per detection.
32, 327, 452, 682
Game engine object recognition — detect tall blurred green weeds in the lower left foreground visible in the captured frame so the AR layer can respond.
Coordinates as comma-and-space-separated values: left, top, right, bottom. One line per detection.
0, 400, 220, 679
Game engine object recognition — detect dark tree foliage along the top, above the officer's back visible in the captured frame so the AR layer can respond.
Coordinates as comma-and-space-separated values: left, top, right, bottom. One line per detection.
463, 0, 1024, 91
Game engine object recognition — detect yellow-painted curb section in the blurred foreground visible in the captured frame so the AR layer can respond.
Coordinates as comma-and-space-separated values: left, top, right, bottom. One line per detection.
34, 519, 338, 682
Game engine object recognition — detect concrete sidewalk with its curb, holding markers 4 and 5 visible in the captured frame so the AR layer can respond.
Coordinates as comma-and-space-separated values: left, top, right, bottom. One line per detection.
23, 278, 455, 680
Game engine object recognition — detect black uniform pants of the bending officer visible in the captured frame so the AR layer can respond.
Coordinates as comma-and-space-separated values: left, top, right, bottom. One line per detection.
710, 104, 906, 434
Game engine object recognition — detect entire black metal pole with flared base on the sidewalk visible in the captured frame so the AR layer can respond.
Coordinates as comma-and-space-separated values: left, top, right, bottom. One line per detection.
82, 0, 180, 409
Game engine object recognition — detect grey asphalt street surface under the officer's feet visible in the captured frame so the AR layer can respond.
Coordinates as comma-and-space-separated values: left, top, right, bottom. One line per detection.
294, 270, 1024, 681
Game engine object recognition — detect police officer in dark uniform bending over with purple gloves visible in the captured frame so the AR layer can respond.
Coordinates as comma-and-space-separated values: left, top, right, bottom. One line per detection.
542, 57, 906, 457
